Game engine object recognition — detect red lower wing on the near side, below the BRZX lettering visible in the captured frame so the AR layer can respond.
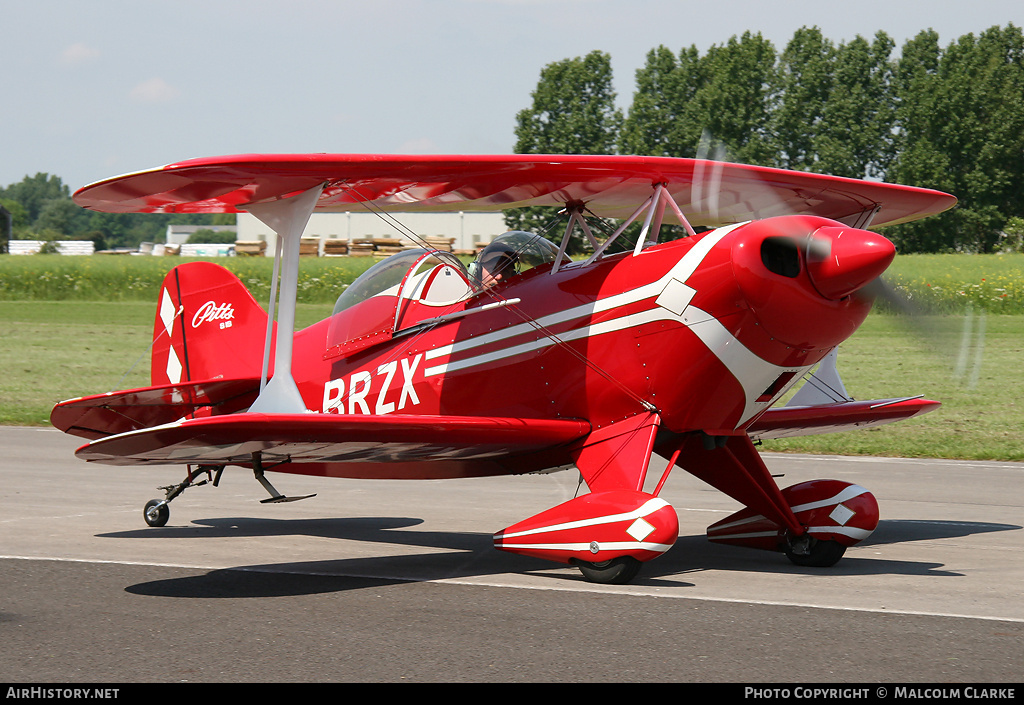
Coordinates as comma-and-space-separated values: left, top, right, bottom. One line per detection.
76, 413, 591, 476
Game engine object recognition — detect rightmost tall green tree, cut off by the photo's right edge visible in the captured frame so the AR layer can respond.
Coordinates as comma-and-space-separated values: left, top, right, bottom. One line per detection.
889, 25, 1024, 252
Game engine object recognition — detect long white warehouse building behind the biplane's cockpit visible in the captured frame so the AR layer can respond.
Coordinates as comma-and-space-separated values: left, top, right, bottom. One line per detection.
238, 212, 508, 256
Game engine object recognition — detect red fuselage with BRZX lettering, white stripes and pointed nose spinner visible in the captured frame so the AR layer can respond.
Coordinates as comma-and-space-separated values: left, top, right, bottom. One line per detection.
282, 216, 894, 474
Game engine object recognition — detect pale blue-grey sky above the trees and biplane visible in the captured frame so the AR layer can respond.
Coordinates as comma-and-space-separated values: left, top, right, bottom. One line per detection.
0, 0, 1024, 192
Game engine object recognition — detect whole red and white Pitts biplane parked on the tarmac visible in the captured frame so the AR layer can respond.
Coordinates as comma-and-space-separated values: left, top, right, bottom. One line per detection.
51, 155, 955, 582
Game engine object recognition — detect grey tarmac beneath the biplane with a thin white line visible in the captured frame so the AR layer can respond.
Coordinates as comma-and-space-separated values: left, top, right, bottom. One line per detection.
0, 427, 1024, 683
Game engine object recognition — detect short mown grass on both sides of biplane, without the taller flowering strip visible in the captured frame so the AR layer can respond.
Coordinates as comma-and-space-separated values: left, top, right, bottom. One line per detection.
0, 301, 1024, 461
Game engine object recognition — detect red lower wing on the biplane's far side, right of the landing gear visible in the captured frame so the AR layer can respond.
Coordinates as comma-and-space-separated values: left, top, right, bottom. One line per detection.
746, 397, 940, 441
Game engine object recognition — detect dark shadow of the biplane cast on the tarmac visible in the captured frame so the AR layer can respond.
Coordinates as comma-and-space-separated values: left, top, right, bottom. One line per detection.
116, 517, 1022, 597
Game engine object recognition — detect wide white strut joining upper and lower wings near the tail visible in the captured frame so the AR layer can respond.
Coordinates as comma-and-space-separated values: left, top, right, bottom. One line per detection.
243, 183, 324, 414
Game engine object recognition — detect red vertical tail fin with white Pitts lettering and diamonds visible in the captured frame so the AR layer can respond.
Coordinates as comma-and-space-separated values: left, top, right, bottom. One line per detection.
151, 261, 267, 385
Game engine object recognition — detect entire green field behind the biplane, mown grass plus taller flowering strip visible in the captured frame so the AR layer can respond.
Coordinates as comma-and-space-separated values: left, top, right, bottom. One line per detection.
6, 254, 1024, 461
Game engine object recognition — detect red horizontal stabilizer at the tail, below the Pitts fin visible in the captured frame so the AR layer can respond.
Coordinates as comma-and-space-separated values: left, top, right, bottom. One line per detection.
50, 377, 260, 440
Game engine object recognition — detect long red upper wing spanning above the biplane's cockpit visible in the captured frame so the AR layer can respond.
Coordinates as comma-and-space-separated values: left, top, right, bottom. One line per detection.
75, 154, 956, 225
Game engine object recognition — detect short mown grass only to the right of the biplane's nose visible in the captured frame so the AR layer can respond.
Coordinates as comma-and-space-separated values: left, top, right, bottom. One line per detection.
762, 314, 1024, 461
